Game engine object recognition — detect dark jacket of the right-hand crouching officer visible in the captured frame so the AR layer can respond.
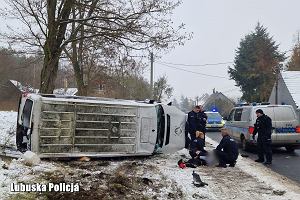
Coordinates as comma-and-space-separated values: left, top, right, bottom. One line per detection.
217, 135, 239, 160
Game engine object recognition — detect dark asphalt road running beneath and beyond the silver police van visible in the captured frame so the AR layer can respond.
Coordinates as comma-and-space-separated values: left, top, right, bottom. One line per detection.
206, 132, 300, 184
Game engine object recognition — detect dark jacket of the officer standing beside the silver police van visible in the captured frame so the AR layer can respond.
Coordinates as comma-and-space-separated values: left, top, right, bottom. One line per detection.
253, 115, 272, 140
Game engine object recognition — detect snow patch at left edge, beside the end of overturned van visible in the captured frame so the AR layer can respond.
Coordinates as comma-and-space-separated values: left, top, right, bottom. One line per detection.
0, 111, 18, 146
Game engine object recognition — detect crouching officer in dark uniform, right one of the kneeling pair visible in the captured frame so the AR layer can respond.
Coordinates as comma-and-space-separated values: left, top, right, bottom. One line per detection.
214, 128, 239, 168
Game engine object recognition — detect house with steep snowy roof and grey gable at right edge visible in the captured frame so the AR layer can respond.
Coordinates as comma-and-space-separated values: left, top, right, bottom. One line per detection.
269, 71, 300, 119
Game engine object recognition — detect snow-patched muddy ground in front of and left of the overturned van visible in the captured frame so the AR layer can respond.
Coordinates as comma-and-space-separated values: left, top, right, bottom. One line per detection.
0, 112, 300, 200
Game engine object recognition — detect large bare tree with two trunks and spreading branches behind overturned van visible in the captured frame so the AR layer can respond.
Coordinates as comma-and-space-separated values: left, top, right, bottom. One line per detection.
5, 0, 187, 95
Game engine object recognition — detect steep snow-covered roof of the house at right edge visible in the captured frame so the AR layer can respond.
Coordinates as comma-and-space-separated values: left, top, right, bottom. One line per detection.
281, 71, 300, 107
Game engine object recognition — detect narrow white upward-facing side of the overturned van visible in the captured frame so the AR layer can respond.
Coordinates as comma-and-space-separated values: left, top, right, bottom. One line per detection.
28, 94, 153, 107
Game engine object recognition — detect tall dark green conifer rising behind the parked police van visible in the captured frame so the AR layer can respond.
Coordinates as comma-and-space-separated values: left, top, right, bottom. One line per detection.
228, 23, 285, 102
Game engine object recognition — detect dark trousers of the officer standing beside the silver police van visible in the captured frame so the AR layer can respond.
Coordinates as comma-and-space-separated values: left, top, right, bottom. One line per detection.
257, 139, 272, 162
